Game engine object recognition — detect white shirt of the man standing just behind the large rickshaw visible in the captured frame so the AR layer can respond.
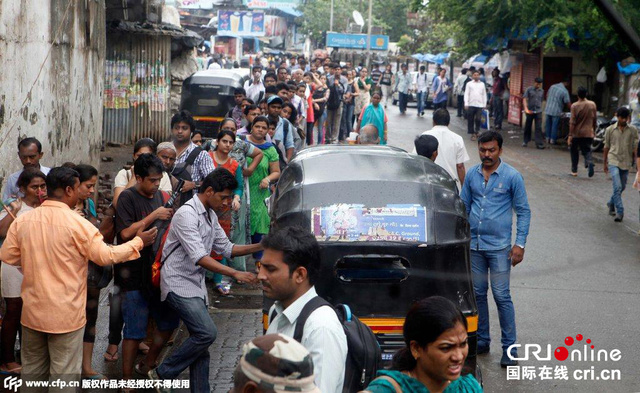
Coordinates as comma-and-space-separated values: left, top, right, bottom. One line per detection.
413, 126, 469, 190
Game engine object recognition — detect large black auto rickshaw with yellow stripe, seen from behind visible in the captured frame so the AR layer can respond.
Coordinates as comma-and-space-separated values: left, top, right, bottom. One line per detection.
265, 145, 481, 381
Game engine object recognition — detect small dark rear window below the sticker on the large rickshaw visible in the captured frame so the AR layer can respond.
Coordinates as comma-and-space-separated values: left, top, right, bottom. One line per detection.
335, 255, 411, 283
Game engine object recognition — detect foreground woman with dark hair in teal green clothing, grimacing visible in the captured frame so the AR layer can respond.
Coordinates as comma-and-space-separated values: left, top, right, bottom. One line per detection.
364, 296, 482, 393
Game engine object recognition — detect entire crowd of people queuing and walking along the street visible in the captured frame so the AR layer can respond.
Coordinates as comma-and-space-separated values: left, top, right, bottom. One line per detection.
0, 52, 640, 393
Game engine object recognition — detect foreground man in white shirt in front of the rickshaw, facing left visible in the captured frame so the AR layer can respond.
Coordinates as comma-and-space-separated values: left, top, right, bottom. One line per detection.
258, 227, 348, 393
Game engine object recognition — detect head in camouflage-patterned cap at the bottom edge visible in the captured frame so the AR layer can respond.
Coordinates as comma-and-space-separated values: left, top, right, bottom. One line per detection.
231, 334, 320, 393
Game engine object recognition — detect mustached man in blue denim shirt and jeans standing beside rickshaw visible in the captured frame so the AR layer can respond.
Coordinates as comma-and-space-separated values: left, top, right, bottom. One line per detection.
460, 131, 531, 367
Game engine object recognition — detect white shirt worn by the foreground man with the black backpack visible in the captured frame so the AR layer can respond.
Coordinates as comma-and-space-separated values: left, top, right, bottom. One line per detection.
266, 287, 347, 393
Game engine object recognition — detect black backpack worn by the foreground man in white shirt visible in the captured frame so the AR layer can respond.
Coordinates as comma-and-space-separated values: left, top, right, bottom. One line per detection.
269, 296, 382, 393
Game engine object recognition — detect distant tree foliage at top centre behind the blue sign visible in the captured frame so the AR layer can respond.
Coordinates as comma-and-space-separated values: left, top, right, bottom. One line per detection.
299, 0, 412, 44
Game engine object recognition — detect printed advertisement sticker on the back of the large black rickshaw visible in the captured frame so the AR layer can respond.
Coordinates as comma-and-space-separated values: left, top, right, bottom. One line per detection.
311, 204, 427, 242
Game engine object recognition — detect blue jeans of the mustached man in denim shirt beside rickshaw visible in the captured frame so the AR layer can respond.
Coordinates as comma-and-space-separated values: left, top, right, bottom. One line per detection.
471, 247, 516, 351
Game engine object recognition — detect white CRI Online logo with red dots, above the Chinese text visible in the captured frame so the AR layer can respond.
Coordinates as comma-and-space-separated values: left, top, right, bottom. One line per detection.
507, 334, 622, 362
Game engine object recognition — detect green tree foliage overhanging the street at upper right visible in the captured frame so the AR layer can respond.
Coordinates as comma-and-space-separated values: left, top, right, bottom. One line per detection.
412, 0, 640, 57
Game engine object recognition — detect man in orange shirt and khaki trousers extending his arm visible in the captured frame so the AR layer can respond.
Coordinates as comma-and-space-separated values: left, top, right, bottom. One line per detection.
0, 168, 157, 381
